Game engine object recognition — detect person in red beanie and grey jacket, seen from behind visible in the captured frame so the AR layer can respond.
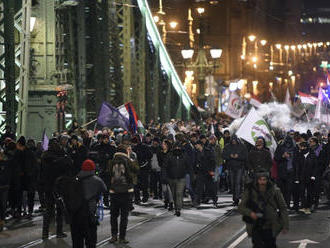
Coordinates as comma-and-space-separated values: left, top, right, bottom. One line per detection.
71, 159, 107, 248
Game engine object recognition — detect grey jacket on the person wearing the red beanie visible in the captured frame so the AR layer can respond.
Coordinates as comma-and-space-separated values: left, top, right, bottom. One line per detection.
77, 171, 107, 213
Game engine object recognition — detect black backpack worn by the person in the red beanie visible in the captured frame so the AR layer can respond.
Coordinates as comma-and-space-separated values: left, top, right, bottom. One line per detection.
55, 175, 93, 219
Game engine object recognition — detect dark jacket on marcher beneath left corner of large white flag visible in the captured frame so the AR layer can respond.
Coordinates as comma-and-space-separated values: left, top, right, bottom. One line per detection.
222, 136, 248, 169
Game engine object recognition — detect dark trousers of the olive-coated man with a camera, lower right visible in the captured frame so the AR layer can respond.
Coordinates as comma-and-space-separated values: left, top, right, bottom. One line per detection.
252, 228, 276, 248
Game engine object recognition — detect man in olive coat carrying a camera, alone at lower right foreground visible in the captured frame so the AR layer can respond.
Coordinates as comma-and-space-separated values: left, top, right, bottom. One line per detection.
238, 169, 289, 248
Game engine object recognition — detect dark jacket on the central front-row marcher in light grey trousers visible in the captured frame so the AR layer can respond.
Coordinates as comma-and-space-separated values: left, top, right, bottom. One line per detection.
164, 152, 191, 179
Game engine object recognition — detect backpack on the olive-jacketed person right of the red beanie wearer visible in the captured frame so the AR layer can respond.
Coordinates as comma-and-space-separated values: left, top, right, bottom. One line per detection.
110, 157, 132, 193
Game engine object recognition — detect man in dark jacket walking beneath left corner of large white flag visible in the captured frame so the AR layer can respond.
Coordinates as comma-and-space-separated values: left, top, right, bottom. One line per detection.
222, 135, 248, 206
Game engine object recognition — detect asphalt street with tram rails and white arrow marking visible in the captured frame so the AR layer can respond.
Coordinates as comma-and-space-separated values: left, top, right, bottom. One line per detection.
0, 195, 330, 248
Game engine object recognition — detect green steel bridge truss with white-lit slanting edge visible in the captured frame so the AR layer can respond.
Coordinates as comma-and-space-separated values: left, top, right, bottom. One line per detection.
0, 0, 193, 138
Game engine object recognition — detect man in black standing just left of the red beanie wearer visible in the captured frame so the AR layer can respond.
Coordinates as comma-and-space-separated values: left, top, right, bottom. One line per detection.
41, 139, 73, 240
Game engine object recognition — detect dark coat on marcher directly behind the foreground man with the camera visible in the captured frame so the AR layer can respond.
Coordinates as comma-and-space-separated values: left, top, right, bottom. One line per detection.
247, 148, 273, 172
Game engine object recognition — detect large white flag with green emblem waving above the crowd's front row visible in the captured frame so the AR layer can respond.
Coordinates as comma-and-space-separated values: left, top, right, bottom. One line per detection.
236, 108, 277, 154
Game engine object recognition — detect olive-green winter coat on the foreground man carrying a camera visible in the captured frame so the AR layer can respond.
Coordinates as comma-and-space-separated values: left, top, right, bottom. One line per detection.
238, 182, 289, 237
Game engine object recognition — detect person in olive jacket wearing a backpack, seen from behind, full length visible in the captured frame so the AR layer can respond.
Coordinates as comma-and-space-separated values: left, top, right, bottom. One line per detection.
108, 145, 139, 244
